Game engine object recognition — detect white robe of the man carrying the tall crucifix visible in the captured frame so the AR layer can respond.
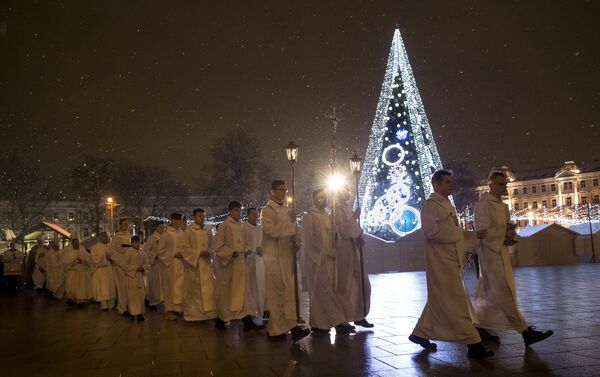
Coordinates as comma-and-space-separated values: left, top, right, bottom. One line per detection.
302, 207, 346, 330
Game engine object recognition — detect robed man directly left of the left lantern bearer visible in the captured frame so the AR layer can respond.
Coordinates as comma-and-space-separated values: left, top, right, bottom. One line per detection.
243, 207, 267, 325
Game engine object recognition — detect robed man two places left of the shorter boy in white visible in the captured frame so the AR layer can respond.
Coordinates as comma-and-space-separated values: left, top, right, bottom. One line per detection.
90, 232, 117, 311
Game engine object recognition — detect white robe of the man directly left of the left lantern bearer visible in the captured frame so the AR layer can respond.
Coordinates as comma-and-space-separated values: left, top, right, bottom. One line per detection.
243, 221, 267, 316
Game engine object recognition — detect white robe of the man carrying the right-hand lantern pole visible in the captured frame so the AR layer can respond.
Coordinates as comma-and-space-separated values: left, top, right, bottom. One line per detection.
335, 205, 371, 322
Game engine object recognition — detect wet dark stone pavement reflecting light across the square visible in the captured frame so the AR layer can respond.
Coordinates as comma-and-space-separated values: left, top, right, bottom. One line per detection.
0, 264, 600, 377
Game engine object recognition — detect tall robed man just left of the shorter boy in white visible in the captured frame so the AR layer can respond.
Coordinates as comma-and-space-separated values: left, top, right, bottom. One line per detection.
109, 218, 132, 317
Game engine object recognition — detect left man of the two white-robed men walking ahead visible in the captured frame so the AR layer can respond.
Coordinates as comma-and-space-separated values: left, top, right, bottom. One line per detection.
408, 170, 494, 358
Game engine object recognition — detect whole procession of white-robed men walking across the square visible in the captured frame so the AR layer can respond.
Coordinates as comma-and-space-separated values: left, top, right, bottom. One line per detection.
2, 170, 552, 352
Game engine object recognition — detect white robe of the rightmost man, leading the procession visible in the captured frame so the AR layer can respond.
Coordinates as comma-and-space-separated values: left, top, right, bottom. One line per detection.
473, 193, 528, 332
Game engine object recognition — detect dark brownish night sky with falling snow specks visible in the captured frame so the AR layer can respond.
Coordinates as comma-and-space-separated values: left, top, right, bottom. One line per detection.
0, 0, 600, 188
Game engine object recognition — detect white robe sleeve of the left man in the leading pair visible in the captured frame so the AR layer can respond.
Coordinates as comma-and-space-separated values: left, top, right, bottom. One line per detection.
421, 200, 462, 244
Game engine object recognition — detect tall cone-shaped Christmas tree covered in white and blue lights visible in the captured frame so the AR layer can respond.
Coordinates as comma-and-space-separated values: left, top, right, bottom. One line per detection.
358, 29, 442, 241
